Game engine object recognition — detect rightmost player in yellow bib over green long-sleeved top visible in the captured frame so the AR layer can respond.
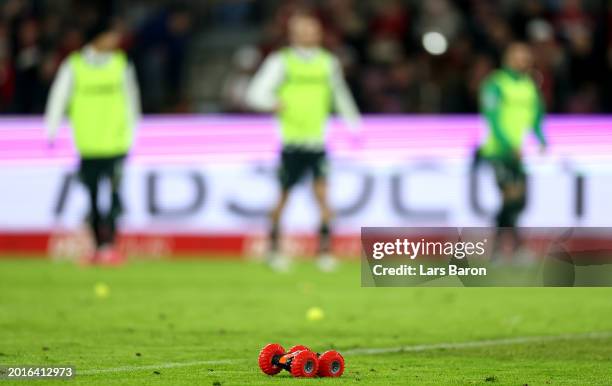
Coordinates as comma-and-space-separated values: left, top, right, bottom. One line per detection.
478, 43, 546, 256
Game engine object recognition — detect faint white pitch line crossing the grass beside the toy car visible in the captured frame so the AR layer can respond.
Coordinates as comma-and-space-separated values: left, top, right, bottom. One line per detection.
75, 331, 612, 376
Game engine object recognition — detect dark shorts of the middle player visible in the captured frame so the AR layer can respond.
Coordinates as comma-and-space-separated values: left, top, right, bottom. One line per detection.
278, 148, 327, 190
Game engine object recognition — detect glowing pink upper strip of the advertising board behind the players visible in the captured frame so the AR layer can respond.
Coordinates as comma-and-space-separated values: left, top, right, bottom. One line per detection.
0, 115, 612, 166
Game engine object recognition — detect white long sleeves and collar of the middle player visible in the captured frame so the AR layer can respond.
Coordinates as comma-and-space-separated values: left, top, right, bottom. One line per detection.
246, 47, 361, 131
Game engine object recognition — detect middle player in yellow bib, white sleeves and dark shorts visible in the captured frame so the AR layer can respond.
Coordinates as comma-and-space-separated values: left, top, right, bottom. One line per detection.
247, 12, 359, 270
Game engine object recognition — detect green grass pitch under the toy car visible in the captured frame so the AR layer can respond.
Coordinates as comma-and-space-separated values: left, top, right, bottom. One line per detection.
0, 259, 612, 385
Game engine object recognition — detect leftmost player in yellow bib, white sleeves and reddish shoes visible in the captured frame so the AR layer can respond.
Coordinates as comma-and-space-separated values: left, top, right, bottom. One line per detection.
45, 22, 140, 264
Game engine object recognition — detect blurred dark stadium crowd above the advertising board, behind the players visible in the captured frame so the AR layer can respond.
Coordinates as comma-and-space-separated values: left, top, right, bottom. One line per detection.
0, 0, 612, 114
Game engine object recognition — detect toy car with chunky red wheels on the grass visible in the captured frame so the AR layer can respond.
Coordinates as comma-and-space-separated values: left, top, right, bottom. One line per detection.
259, 343, 344, 377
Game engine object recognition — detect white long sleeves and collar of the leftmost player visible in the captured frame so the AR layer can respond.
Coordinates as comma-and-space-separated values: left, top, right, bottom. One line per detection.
45, 46, 142, 141
